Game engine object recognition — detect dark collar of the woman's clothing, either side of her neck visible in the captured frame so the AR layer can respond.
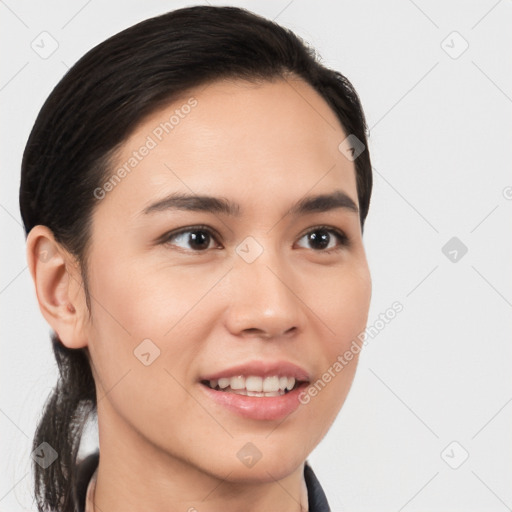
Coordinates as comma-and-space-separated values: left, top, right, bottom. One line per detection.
75, 452, 331, 512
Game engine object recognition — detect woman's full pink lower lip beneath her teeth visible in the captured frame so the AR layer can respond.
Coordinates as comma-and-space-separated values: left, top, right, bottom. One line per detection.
199, 382, 308, 421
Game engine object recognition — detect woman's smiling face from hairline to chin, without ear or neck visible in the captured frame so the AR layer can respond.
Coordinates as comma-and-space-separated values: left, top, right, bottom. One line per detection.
85, 76, 371, 481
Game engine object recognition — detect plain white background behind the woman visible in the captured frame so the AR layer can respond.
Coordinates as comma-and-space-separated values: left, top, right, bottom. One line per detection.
0, 0, 512, 512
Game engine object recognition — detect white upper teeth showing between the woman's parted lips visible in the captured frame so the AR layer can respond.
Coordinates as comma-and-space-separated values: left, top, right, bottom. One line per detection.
201, 375, 306, 397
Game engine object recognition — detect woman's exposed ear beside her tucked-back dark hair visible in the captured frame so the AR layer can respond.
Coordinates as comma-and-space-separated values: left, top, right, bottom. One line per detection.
27, 225, 89, 348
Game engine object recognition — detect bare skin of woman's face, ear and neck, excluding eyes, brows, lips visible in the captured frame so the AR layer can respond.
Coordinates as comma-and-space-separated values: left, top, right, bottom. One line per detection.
27, 79, 371, 512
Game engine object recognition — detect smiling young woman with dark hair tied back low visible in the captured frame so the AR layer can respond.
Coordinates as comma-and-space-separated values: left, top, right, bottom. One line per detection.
20, 6, 372, 512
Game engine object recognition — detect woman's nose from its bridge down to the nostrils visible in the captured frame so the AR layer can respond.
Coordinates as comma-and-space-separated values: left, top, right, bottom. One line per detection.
228, 237, 301, 337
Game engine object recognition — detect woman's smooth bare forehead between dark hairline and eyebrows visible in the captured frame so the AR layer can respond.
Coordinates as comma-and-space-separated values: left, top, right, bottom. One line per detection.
93, 78, 357, 220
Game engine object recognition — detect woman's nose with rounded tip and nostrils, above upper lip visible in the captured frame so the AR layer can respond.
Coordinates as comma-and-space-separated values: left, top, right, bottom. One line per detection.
226, 250, 305, 339
